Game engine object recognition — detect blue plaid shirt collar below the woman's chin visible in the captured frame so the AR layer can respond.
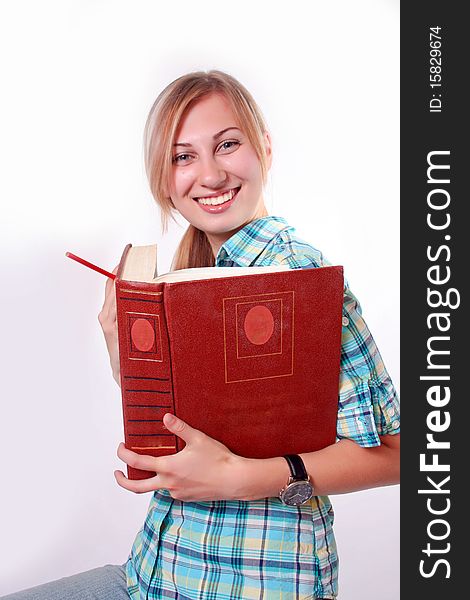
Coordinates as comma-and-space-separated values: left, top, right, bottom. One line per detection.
215, 216, 289, 267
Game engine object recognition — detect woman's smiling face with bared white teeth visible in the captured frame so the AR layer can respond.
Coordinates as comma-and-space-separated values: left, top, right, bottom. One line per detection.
170, 93, 271, 254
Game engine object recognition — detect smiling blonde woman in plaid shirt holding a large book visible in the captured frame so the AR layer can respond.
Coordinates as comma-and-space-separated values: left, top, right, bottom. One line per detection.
3, 71, 400, 600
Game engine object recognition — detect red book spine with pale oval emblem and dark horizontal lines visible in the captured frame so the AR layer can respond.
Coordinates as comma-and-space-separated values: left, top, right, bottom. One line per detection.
116, 280, 178, 479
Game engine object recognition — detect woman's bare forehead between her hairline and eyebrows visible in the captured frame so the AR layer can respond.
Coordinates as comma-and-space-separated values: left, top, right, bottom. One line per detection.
176, 93, 239, 142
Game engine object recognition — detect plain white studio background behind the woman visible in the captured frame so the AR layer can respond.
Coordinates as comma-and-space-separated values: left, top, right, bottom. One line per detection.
0, 0, 399, 600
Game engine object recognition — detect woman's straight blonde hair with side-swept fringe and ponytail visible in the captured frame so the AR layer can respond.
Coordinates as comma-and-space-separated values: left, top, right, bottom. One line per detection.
144, 70, 268, 269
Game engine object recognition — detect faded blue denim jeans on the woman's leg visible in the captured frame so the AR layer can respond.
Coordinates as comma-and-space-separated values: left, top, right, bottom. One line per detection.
1, 565, 129, 600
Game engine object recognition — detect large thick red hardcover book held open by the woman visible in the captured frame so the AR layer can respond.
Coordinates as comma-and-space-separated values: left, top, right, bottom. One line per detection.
115, 245, 343, 479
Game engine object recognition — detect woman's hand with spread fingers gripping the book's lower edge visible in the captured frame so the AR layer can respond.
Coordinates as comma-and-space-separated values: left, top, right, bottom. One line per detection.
114, 413, 246, 502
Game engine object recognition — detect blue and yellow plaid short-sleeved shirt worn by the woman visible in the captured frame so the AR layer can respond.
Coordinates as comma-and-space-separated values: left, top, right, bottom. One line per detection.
127, 216, 400, 600
